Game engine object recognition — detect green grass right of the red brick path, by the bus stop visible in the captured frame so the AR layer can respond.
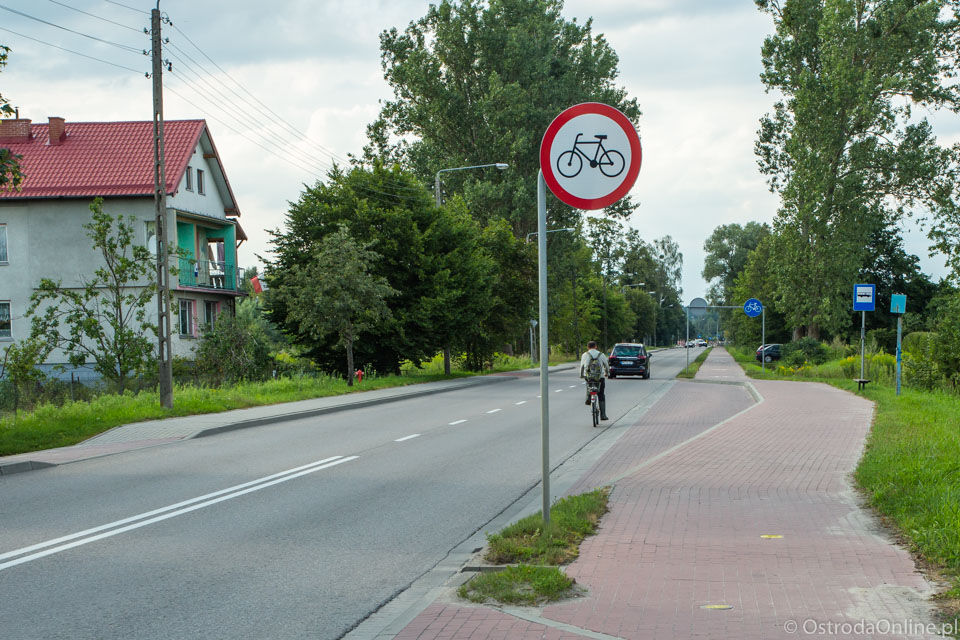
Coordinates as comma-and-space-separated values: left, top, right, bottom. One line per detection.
729, 350, 960, 599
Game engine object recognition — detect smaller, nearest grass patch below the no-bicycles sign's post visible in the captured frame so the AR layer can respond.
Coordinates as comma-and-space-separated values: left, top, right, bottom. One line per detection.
457, 565, 574, 606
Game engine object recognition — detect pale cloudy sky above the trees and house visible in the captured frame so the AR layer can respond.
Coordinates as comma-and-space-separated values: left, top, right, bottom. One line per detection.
0, 0, 960, 302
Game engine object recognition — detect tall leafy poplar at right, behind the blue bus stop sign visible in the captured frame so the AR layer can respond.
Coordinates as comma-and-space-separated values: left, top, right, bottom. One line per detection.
756, 0, 960, 338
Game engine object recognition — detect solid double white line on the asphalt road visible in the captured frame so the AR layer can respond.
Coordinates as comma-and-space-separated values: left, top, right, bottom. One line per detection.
0, 456, 359, 571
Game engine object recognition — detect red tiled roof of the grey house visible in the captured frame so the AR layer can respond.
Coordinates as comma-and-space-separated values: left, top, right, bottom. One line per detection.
0, 120, 206, 199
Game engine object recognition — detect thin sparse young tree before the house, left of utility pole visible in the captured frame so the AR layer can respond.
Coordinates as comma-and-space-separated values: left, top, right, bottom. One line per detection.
27, 198, 157, 391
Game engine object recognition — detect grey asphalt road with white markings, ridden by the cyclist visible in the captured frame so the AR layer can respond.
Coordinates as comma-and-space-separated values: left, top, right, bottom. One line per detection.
0, 349, 701, 640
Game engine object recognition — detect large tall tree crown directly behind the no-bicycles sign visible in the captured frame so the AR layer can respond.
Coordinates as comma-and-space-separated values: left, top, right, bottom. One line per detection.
365, 0, 640, 237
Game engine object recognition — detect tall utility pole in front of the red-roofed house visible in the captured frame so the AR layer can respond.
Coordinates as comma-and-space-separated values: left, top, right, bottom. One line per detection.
150, 6, 173, 409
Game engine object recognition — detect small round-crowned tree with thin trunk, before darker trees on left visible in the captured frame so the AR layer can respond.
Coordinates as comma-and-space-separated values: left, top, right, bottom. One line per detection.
280, 226, 397, 386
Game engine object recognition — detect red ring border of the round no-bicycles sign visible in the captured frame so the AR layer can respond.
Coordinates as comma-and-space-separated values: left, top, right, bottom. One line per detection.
540, 102, 642, 209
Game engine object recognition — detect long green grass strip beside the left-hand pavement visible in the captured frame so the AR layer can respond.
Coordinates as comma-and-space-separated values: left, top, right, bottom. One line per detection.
0, 356, 564, 456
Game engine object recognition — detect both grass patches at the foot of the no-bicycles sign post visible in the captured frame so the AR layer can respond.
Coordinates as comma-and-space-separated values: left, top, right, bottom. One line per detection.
458, 487, 610, 605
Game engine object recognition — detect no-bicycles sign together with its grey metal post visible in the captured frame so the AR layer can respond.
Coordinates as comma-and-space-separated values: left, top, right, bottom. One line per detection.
537, 102, 642, 525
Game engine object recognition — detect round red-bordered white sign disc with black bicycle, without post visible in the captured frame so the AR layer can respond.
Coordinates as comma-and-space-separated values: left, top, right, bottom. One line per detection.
540, 102, 641, 209
